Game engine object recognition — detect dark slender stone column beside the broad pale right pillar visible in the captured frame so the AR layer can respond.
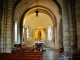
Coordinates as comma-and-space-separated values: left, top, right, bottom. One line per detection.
68, 0, 76, 53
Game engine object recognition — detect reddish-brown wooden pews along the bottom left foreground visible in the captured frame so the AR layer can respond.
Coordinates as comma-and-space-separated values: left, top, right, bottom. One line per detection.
0, 52, 42, 60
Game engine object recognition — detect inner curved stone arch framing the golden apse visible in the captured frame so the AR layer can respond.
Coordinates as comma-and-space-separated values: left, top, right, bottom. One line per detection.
20, 6, 57, 41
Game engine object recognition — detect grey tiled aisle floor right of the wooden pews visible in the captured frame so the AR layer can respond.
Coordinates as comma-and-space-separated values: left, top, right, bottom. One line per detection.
42, 48, 64, 60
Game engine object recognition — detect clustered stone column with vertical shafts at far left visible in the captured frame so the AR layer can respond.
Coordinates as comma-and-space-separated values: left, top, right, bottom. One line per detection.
1, 0, 13, 53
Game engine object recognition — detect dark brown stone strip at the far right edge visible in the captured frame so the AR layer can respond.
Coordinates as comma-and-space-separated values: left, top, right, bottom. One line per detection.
74, 0, 80, 52
